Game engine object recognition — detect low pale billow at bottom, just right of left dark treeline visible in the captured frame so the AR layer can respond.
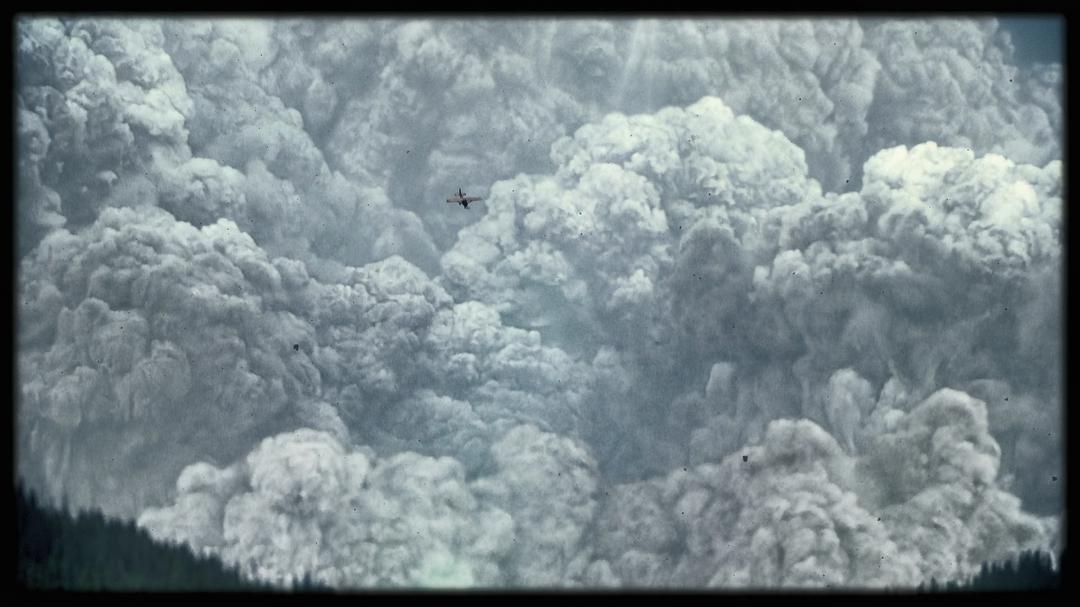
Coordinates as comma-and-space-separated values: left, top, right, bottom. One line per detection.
139, 429, 514, 588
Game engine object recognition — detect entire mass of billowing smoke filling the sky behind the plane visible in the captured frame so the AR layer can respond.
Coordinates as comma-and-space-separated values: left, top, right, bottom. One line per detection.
14, 16, 1066, 589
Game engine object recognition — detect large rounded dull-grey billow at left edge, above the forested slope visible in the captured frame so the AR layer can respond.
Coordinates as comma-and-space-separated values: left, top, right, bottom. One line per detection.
17, 206, 343, 514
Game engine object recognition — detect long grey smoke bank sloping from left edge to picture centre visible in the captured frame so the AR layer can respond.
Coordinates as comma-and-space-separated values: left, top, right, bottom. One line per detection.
18, 199, 589, 514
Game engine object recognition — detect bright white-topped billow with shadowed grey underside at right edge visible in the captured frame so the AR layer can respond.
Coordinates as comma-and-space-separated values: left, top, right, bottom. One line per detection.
752, 144, 1062, 512
